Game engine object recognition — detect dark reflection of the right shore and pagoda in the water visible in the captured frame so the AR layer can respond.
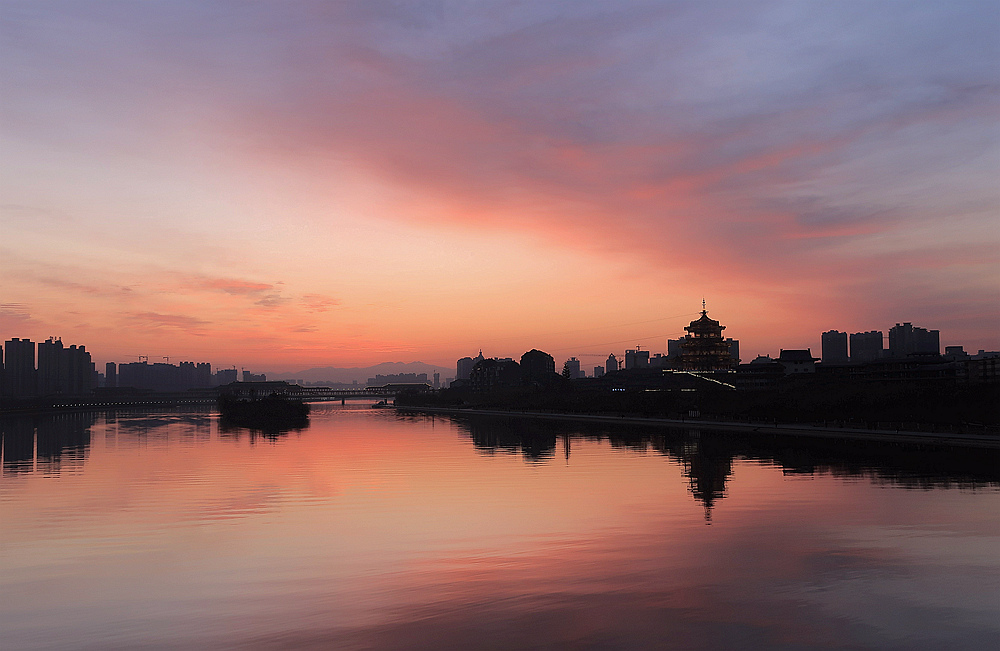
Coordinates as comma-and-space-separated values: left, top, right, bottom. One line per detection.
454, 416, 1000, 521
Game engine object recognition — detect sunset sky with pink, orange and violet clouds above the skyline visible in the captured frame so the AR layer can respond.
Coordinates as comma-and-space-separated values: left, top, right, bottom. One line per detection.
0, 0, 1000, 371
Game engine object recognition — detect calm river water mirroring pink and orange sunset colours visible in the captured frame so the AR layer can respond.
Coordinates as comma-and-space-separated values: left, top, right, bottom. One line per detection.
0, 406, 1000, 649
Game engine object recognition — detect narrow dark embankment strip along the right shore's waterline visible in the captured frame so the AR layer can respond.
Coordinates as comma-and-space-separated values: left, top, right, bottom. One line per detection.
396, 406, 1000, 449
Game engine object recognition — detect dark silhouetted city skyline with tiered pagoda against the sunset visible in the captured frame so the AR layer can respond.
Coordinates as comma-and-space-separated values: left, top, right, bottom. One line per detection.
0, 314, 1000, 398
